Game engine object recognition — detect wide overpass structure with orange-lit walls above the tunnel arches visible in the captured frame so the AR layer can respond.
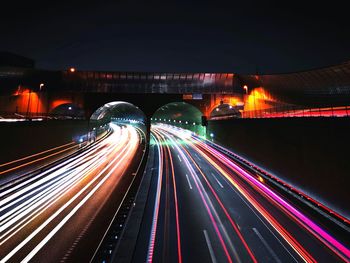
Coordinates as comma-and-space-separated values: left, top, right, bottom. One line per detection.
0, 59, 350, 120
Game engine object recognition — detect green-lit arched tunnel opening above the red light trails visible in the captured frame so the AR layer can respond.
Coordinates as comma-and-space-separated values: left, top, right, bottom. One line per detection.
151, 102, 205, 136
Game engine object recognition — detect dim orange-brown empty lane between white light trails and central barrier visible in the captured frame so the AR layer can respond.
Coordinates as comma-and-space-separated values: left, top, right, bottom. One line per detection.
33, 136, 141, 262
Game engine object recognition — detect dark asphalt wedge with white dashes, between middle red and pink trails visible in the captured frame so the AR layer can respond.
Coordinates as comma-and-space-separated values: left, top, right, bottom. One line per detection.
172, 146, 227, 262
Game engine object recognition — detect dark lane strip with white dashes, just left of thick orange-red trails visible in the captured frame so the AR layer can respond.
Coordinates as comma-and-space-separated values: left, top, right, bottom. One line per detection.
183, 147, 300, 262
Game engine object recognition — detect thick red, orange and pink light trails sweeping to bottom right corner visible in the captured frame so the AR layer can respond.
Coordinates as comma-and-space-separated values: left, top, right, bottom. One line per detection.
154, 125, 350, 262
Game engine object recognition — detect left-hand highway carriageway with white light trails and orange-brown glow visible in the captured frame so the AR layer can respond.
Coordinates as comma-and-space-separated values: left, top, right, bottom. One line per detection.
0, 123, 142, 262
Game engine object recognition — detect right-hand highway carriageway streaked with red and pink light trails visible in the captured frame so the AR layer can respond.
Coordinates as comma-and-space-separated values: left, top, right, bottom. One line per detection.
132, 124, 350, 262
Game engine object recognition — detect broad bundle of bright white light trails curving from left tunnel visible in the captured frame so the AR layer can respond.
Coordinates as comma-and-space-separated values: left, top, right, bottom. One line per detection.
0, 124, 140, 262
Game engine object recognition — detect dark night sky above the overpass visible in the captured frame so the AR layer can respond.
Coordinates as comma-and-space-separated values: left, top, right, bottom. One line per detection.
0, 0, 350, 73
